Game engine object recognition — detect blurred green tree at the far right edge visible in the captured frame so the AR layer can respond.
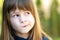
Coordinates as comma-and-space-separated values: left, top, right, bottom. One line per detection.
51, 0, 60, 37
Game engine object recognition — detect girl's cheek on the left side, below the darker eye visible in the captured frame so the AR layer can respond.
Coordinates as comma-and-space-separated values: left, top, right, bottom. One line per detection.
10, 18, 21, 31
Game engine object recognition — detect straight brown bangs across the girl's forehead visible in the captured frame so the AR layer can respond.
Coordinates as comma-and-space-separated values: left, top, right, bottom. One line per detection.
4, 0, 32, 13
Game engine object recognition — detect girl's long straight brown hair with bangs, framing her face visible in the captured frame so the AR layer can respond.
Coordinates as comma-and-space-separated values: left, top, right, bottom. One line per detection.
2, 0, 51, 40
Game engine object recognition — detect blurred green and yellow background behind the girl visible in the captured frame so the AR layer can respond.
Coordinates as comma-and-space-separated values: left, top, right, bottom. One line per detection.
0, 0, 60, 40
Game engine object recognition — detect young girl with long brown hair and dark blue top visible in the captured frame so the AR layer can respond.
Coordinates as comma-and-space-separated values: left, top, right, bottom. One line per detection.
1, 0, 52, 40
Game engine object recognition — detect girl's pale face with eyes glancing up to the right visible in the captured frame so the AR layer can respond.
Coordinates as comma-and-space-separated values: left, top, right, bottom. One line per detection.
10, 9, 35, 33
